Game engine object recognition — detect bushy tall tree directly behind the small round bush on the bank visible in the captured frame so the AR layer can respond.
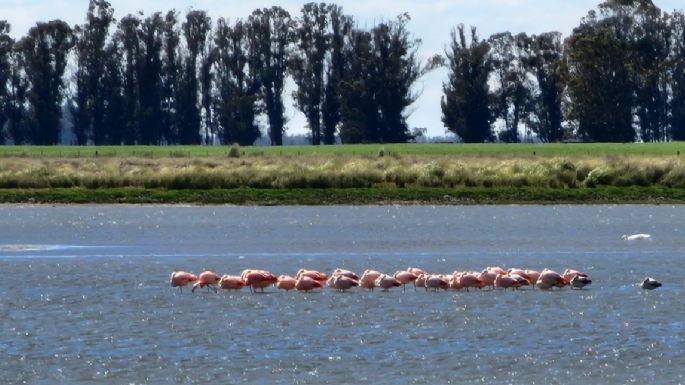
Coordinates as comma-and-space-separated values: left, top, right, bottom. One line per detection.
213, 19, 261, 145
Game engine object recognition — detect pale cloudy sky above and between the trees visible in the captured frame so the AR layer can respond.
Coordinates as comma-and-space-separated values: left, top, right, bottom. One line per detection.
0, 0, 685, 136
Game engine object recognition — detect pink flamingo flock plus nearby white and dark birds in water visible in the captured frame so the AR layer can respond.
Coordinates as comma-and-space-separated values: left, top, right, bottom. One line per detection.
170, 234, 661, 293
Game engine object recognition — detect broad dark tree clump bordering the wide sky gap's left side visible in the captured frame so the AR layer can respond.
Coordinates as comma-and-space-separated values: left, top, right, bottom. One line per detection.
340, 14, 422, 143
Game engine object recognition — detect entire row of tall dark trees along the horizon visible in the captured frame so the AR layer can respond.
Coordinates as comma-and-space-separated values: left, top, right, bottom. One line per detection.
0, 0, 685, 145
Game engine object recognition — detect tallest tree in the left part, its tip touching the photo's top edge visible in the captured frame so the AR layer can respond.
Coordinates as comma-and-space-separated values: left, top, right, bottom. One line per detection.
71, 0, 114, 145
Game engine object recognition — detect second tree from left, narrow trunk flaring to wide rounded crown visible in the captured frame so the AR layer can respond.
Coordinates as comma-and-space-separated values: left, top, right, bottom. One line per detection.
19, 20, 73, 145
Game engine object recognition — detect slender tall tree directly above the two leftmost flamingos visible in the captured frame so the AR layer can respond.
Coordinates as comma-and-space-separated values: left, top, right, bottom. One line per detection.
178, 11, 212, 144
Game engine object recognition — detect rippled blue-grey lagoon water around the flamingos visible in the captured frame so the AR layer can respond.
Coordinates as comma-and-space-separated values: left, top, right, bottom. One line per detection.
0, 205, 685, 384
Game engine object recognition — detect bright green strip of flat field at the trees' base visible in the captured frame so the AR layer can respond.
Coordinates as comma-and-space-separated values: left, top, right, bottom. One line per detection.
0, 142, 685, 158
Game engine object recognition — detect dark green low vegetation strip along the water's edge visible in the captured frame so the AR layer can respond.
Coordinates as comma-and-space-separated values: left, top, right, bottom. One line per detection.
0, 186, 685, 206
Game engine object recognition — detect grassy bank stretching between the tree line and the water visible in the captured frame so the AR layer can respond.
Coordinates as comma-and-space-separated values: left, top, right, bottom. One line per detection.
0, 143, 685, 205
